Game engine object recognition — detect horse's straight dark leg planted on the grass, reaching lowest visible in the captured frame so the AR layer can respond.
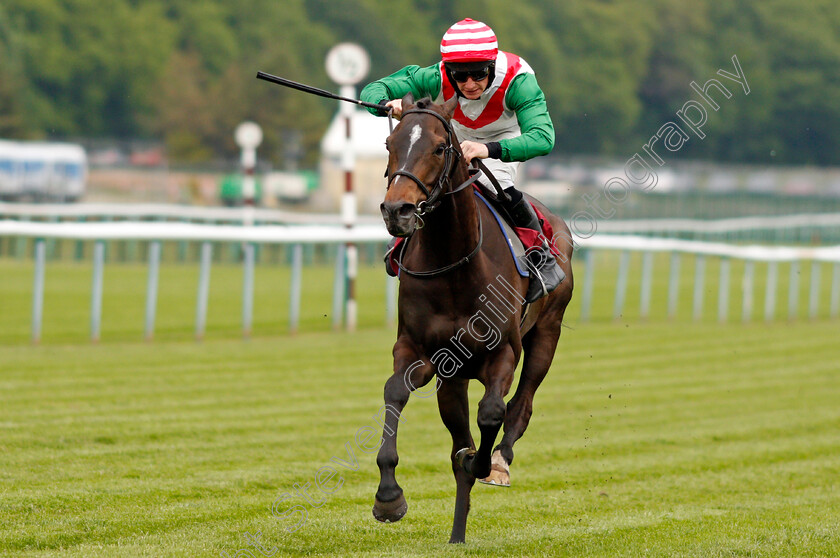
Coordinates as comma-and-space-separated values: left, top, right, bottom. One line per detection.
437, 378, 475, 543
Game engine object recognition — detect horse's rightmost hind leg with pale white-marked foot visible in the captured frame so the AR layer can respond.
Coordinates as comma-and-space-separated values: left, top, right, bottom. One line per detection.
488, 320, 562, 486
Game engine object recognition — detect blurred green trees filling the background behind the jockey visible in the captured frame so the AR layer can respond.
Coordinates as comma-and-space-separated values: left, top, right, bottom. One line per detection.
0, 0, 840, 165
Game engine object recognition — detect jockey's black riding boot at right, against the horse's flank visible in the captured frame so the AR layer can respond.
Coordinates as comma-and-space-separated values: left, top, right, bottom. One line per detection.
505, 194, 566, 302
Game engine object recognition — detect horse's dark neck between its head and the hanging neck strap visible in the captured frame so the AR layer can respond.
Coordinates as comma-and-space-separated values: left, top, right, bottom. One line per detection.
415, 167, 480, 265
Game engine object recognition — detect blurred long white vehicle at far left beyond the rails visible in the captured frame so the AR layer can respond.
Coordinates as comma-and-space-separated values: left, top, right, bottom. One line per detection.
0, 140, 88, 201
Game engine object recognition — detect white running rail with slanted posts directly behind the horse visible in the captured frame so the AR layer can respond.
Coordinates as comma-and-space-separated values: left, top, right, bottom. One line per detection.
0, 220, 840, 343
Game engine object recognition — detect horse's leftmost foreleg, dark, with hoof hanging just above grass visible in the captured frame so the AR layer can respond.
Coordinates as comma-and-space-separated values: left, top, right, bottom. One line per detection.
373, 349, 434, 522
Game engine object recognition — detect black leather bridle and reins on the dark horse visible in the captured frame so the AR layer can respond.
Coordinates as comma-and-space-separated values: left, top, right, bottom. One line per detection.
385, 108, 484, 279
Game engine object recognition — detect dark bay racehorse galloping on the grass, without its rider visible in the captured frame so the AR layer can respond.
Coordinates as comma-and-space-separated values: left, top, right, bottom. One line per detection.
373, 94, 572, 543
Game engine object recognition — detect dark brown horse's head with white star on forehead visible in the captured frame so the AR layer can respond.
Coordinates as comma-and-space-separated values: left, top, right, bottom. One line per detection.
380, 93, 461, 236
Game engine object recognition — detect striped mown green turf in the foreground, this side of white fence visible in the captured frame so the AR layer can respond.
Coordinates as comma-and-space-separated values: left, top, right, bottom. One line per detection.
0, 316, 840, 557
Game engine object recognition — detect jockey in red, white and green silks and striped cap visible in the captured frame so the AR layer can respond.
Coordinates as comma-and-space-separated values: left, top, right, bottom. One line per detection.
361, 18, 565, 302
